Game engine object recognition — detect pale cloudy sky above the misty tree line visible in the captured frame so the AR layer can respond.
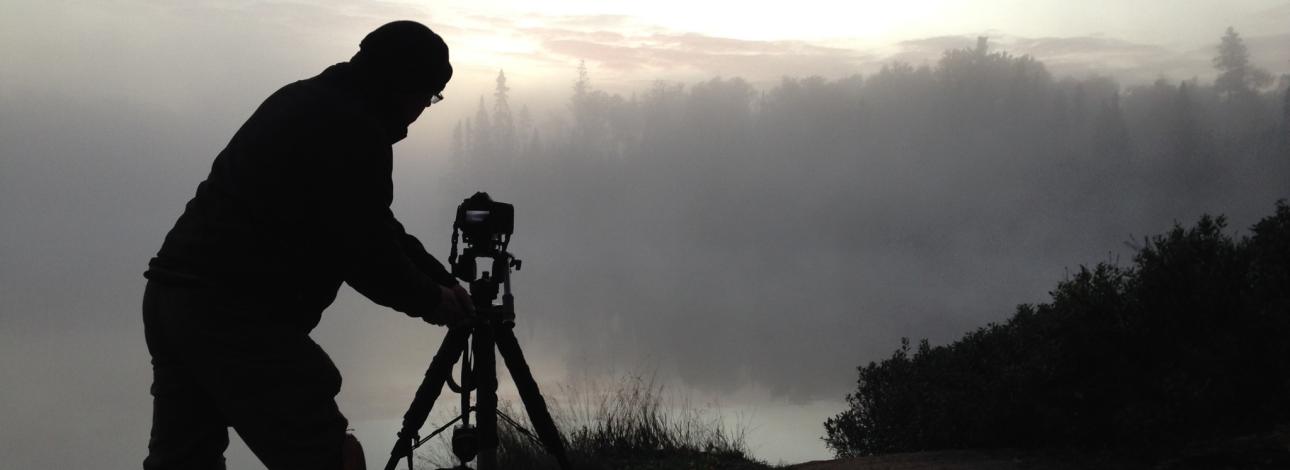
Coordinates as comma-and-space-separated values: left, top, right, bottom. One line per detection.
0, 0, 1290, 103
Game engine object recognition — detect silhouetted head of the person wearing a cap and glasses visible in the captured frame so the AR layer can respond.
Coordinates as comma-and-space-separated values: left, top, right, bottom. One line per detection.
350, 21, 453, 127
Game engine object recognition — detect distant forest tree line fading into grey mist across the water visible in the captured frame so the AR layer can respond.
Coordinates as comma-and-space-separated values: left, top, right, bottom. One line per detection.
453, 28, 1290, 246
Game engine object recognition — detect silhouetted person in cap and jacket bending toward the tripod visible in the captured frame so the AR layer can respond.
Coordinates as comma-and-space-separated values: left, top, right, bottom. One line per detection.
143, 22, 471, 469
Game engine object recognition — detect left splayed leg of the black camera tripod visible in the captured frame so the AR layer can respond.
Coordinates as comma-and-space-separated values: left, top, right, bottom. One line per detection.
386, 328, 471, 470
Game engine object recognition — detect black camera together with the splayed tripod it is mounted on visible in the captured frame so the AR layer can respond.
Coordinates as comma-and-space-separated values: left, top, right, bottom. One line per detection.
386, 192, 571, 470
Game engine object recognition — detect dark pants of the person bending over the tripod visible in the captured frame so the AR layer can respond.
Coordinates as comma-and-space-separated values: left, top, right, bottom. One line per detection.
143, 280, 348, 470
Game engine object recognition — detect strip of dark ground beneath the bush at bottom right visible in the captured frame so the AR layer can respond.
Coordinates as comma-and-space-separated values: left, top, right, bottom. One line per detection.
788, 427, 1290, 470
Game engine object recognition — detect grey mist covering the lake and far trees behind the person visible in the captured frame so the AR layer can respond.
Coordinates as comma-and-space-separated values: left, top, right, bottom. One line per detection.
0, 2, 1290, 467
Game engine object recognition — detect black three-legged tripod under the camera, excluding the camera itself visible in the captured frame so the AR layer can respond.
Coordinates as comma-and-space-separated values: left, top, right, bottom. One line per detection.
386, 246, 571, 470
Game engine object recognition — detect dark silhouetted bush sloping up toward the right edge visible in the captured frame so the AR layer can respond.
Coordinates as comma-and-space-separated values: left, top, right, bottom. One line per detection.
824, 201, 1290, 456
